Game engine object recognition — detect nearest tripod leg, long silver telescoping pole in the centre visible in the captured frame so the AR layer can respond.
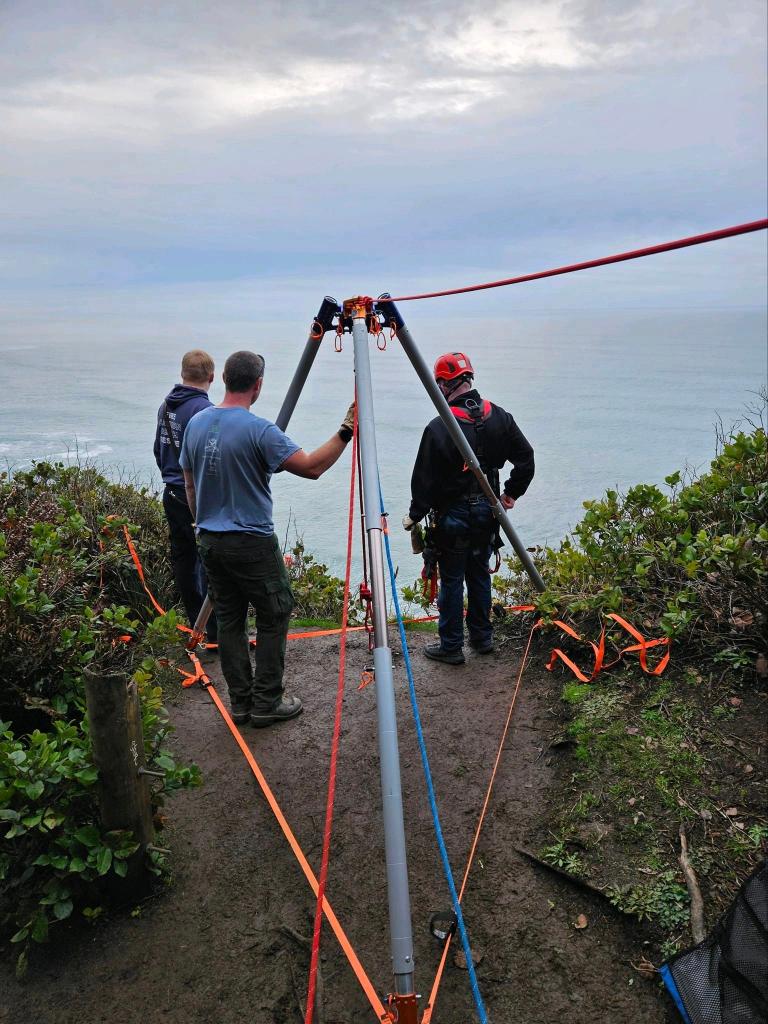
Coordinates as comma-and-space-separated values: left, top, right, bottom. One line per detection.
350, 298, 417, 1024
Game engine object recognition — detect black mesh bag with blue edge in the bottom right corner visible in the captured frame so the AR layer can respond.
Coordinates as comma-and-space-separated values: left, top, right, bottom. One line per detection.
660, 860, 768, 1024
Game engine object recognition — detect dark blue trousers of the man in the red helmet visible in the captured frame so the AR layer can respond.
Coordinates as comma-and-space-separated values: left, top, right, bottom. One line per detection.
437, 498, 495, 650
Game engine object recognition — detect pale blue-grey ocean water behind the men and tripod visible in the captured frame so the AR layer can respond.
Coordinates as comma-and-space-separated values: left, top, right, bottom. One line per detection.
0, 309, 768, 581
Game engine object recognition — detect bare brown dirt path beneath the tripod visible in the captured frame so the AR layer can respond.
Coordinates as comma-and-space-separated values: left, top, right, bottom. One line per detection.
0, 634, 675, 1024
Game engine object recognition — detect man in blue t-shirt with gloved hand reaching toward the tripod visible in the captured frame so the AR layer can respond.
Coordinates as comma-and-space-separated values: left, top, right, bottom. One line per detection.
179, 352, 354, 726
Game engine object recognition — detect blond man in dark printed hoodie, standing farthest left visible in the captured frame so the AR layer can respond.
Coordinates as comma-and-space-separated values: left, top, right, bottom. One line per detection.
155, 348, 217, 643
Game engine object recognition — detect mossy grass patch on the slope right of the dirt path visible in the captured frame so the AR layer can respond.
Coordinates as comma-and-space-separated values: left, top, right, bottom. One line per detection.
540, 670, 768, 958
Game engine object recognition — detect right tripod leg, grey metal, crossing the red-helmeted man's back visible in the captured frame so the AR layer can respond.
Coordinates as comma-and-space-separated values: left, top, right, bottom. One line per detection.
376, 294, 547, 593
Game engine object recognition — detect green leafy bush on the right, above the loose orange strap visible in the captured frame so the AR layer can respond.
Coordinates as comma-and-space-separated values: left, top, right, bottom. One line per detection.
495, 419, 768, 670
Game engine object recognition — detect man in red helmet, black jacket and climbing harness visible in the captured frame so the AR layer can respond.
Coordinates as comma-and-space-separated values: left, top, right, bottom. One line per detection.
402, 352, 535, 665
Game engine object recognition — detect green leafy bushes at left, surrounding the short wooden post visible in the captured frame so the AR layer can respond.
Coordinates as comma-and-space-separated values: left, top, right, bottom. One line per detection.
0, 463, 200, 969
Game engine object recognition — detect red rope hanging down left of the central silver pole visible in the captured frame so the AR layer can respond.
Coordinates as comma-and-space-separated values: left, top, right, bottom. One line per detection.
304, 404, 357, 1024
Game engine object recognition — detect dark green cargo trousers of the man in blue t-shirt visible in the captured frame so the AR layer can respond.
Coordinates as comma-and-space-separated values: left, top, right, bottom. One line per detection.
199, 529, 294, 714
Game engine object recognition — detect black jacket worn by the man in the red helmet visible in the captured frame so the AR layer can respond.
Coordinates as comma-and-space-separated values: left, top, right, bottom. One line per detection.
409, 390, 535, 522
